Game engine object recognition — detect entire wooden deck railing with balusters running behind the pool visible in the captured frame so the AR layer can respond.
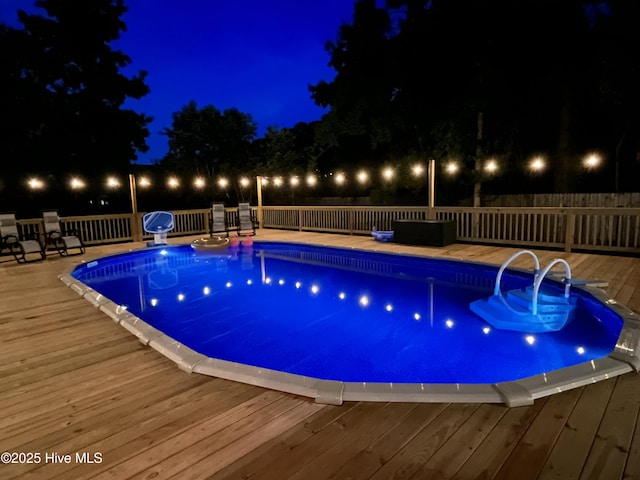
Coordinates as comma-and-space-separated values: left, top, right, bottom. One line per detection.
12, 206, 640, 254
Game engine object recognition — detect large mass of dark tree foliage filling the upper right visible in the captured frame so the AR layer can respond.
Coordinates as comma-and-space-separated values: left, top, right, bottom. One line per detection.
310, 0, 640, 195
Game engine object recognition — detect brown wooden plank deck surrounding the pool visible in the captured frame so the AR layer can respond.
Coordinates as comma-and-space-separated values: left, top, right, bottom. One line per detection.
0, 230, 640, 480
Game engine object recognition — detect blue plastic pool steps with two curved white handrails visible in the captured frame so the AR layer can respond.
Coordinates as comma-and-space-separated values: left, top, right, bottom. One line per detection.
469, 250, 576, 333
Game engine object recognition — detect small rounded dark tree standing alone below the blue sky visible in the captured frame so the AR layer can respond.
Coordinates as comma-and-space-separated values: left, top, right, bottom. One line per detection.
160, 101, 257, 197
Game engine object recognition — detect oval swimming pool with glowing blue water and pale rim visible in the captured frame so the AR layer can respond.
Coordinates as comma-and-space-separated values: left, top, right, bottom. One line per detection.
61, 242, 638, 405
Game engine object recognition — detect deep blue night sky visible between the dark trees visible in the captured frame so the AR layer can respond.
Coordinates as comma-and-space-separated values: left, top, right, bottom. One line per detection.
0, 0, 354, 163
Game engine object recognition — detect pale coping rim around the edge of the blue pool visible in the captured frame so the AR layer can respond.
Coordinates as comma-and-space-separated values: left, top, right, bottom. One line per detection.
58, 242, 640, 407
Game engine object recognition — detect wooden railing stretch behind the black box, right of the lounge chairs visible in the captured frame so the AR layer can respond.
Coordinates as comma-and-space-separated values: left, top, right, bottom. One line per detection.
263, 207, 640, 253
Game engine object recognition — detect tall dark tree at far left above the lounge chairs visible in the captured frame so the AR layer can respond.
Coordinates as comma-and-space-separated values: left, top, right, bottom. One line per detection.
0, 0, 151, 174
